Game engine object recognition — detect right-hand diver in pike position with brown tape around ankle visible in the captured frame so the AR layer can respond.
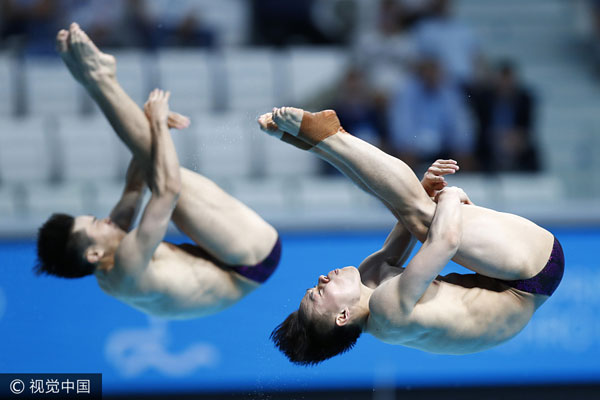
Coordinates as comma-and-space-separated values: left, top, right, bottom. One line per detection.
258, 107, 564, 365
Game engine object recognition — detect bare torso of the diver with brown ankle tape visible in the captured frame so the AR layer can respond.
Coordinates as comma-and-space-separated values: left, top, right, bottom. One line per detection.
365, 266, 548, 354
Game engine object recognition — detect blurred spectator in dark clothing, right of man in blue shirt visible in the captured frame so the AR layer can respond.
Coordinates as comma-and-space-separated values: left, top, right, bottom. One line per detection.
473, 61, 540, 172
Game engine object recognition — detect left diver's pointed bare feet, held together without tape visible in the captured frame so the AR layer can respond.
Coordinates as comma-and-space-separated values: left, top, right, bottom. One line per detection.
56, 23, 117, 86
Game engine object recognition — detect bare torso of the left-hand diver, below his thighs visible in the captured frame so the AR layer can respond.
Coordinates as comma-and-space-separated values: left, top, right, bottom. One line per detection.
96, 242, 259, 319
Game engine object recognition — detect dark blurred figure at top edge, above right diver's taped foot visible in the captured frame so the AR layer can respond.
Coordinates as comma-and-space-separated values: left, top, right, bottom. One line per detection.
252, 0, 330, 46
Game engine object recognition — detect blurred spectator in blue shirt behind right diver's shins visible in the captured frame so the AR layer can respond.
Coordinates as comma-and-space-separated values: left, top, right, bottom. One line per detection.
388, 54, 475, 172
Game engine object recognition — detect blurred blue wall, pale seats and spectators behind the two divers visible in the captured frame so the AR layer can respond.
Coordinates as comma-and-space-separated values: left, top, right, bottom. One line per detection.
0, 0, 600, 400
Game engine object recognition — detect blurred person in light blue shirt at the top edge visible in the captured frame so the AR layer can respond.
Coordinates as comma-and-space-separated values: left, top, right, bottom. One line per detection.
413, 0, 479, 86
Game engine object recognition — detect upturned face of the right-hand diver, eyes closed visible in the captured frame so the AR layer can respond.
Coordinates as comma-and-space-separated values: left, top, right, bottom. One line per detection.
300, 267, 361, 319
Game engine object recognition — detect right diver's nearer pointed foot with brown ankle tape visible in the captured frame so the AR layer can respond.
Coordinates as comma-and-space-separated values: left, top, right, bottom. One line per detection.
272, 107, 346, 146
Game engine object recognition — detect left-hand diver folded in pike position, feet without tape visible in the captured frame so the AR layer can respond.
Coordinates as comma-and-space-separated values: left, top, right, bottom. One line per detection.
36, 24, 281, 318
